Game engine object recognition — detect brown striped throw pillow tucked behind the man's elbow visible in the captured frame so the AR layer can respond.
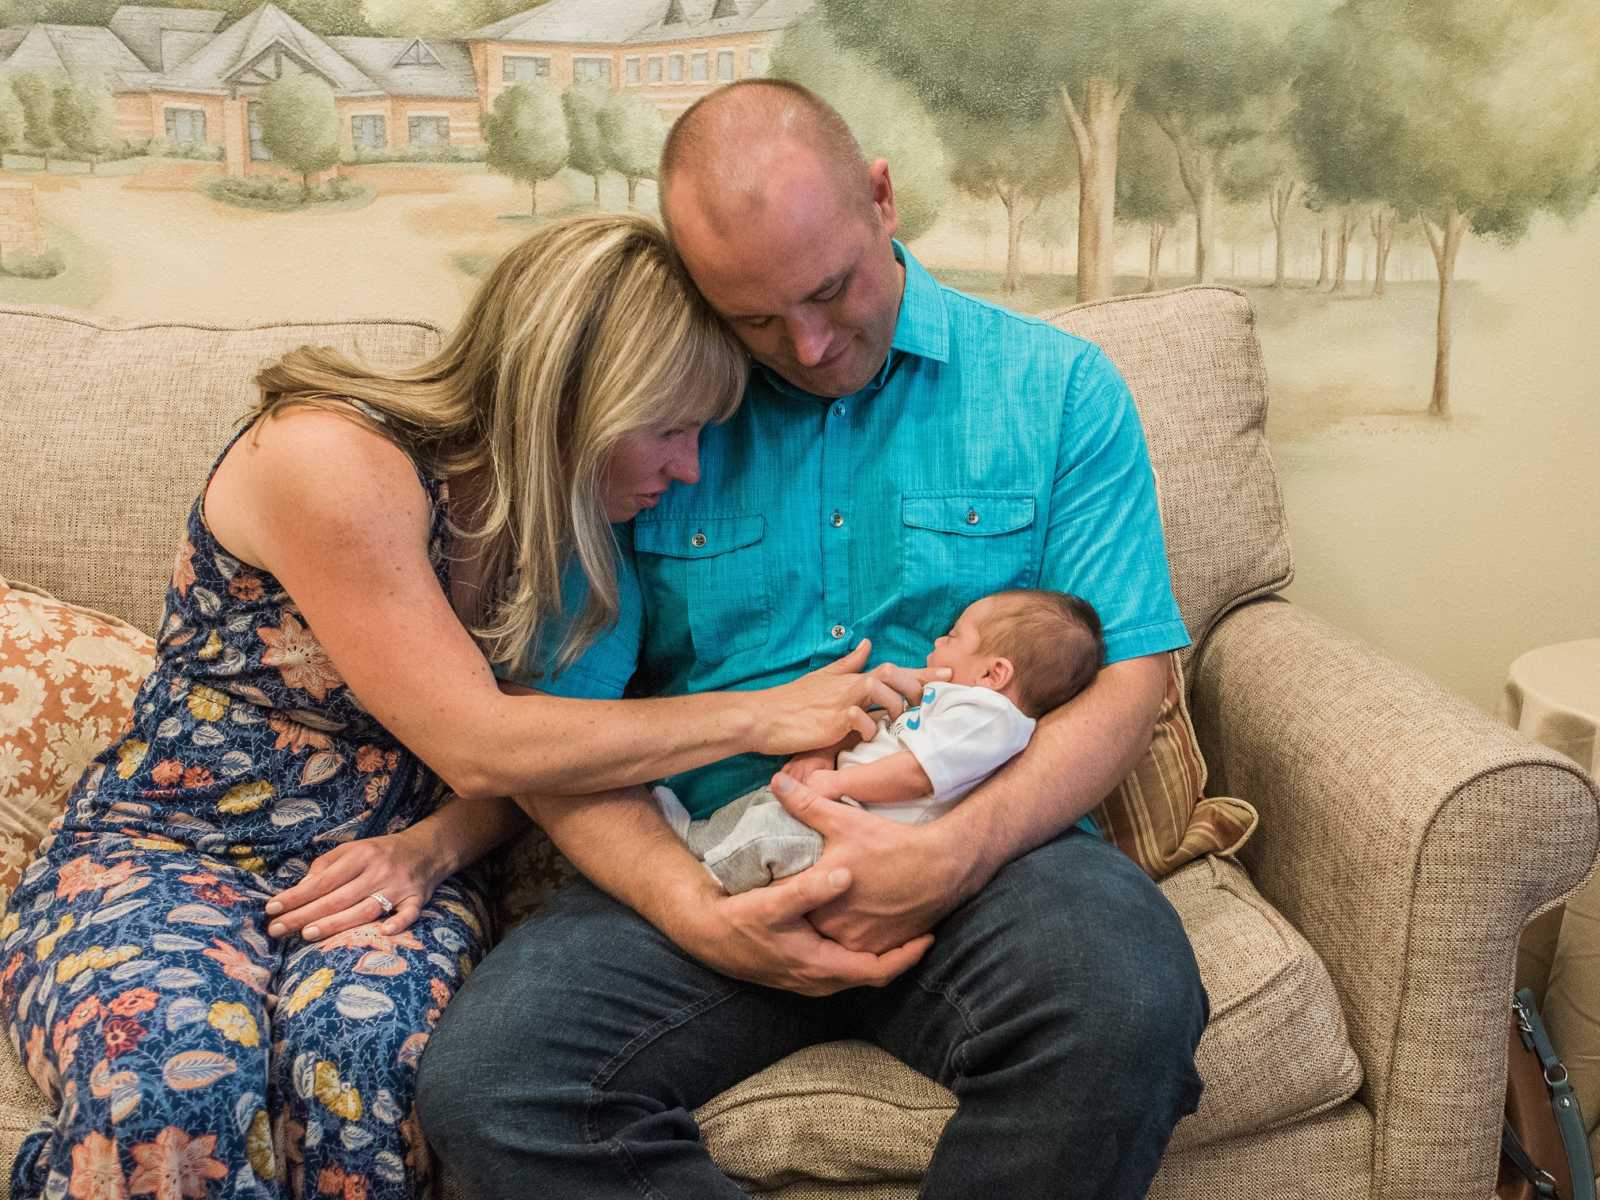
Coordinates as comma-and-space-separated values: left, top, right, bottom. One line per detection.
1093, 654, 1259, 878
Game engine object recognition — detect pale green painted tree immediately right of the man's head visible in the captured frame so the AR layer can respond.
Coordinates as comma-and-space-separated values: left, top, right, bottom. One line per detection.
766, 13, 950, 242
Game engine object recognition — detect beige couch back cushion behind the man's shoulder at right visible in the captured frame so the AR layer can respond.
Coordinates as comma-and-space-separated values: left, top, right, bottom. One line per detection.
1046, 288, 1294, 669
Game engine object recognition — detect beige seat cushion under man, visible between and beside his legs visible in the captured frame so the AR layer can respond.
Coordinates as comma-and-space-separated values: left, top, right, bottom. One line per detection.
696, 858, 1362, 1189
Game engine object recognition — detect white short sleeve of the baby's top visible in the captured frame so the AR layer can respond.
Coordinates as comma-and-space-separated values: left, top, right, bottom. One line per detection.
901, 683, 1035, 802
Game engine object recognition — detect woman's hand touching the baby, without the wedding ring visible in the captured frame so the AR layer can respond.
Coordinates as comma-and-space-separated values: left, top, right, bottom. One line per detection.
750, 638, 950, 754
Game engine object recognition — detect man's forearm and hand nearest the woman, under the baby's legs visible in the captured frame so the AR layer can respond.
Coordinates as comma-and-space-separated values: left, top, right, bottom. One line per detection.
518, 787, 933, 995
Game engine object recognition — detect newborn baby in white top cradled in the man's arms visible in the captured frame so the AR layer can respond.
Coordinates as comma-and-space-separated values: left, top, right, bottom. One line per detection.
656, 590, 1106, 893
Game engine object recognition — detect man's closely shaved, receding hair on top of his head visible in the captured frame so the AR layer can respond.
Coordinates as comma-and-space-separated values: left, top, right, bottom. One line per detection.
656, 78, 872, 229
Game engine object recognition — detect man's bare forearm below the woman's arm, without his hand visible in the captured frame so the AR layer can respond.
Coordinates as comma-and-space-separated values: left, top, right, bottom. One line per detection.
517, 787, 720, 946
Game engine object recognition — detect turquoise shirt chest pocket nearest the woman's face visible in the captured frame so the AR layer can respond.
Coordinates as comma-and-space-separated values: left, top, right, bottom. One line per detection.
634, 515, 773, 662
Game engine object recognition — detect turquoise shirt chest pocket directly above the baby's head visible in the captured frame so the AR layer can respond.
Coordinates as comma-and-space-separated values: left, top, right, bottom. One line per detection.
901, 491, 1037, 624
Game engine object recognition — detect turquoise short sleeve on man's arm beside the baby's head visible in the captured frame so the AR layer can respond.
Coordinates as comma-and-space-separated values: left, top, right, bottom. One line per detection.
1038, 347, 1189, 662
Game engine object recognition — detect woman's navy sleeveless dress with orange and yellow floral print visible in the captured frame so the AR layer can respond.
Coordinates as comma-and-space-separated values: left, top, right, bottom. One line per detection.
0, 422, 488, 1200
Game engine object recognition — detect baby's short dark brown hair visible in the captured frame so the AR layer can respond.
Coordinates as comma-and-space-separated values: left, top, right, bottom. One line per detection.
978, 589, 1106, 717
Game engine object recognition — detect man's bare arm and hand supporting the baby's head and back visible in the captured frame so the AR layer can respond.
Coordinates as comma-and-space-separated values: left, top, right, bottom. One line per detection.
773, 654, 1166, 949
